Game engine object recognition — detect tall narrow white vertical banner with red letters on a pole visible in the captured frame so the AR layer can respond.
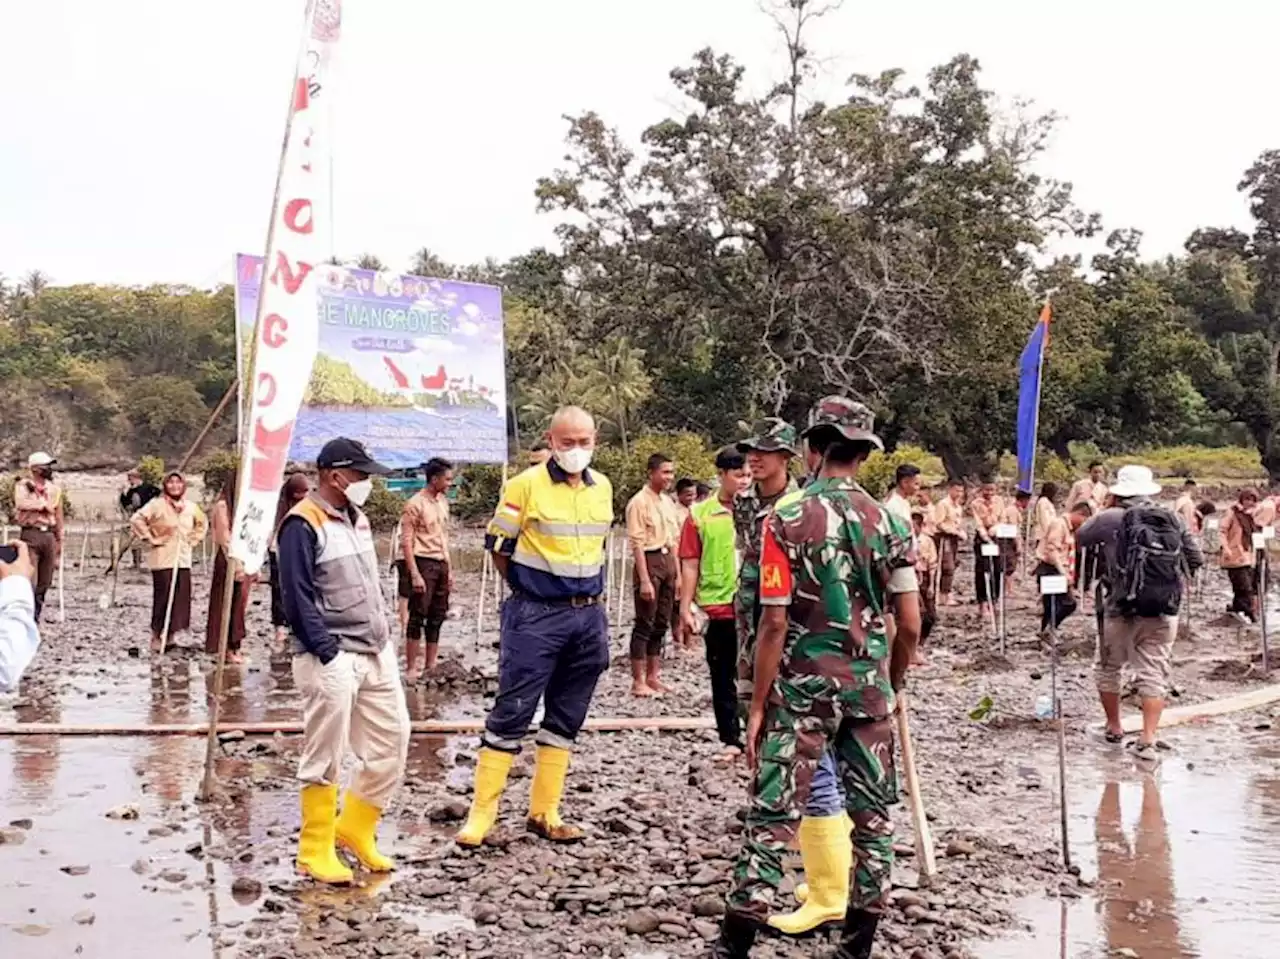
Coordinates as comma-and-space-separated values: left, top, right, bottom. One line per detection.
230, 0, 342, 574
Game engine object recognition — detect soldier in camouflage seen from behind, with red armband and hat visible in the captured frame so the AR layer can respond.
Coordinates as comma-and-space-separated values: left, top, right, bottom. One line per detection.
712, 397, 920, 959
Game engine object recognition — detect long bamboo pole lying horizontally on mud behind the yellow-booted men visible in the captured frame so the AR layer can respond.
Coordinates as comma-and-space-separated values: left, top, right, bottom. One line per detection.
0, 717, 716, 741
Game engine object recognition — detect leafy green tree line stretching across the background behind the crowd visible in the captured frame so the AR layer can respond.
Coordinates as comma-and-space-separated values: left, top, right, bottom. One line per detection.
0, 0, 1280, 479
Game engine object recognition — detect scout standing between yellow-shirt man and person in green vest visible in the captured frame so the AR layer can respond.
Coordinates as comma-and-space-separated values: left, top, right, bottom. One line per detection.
627, 453, 680, 697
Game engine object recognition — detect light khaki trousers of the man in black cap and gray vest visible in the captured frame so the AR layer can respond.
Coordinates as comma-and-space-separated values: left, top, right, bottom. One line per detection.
293, 643, 410, 809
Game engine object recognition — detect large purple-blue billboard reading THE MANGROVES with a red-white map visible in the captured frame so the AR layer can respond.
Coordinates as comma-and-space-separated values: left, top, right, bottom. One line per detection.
236, 254, 507, 469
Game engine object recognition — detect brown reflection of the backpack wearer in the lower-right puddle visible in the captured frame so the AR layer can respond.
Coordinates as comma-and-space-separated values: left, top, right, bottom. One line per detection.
1094, 776, 1196, 959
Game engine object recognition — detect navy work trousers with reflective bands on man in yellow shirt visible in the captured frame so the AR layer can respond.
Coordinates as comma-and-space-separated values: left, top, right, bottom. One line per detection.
484, 594, 609, 753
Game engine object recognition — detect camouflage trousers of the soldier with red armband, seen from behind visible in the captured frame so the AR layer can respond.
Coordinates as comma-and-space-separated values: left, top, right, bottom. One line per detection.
728, 705, 897, 923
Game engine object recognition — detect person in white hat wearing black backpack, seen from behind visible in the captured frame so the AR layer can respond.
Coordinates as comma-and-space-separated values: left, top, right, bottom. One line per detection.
1076, 466, 1204, 764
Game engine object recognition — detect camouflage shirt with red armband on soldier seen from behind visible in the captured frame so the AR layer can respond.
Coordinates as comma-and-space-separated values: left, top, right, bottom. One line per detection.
760, 478, 915, 718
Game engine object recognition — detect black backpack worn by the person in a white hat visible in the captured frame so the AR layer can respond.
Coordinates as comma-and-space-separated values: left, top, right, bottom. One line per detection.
1112, 504, 1183, 616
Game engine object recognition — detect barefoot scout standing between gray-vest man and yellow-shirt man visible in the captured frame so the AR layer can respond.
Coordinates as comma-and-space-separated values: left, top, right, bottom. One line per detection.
401, 457, 453, 684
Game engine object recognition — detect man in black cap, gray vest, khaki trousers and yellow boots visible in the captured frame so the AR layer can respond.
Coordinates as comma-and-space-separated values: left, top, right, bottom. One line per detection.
279, 438, 410, 883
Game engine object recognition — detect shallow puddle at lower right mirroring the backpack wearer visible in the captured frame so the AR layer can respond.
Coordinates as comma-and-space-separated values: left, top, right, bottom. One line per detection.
979, 727, 1280, 959
